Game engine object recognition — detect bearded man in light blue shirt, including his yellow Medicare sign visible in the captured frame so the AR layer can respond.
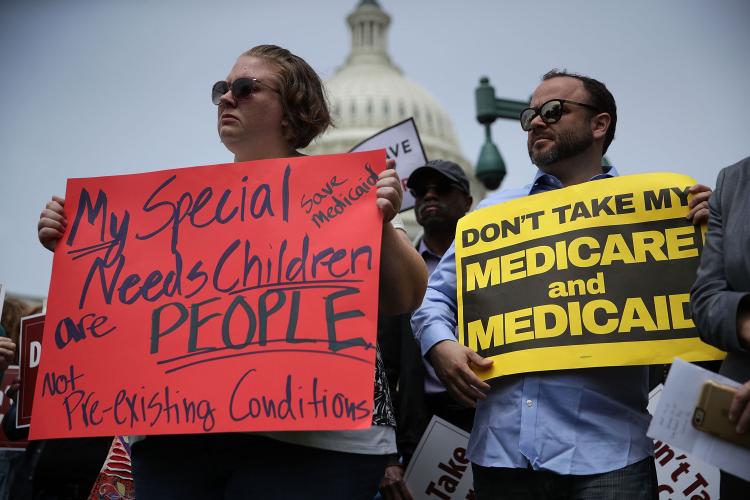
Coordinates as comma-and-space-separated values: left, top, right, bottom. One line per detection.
412, 71, 720, 499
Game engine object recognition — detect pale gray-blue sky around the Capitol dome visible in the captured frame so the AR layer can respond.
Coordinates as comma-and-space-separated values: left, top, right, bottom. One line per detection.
0, 0, 750, 296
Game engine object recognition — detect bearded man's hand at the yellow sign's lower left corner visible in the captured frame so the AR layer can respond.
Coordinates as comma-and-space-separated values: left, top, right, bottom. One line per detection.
427, 340, 492, 408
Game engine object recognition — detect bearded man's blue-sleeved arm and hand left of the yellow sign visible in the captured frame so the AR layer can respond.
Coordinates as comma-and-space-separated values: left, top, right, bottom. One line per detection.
411, 240, 492, 407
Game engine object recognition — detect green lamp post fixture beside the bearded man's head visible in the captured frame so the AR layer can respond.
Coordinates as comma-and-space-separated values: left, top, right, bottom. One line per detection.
474, 76, 529, 190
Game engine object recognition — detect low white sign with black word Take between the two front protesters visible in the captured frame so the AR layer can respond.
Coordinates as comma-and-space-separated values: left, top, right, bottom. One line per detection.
404, 416, 475, 500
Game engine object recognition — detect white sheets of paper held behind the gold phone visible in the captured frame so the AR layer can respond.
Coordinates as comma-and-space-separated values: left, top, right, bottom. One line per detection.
648, 359, 750, 484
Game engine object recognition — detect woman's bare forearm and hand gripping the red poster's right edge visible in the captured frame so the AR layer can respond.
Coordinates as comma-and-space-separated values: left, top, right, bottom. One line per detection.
376, 160, 427, 315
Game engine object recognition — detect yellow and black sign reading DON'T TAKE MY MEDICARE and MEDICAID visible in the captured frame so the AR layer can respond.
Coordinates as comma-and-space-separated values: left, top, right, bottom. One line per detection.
456, 174, 724, 379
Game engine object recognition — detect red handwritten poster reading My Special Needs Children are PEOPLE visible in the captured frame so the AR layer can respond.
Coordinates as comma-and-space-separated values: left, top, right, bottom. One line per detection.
31, 150, 385, 439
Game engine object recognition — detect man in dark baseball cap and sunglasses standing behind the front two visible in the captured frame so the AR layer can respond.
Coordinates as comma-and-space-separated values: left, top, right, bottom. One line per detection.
378, 160, 474, 498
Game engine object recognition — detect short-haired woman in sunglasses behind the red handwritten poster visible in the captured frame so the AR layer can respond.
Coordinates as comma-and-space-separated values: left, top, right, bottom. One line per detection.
38, 45, 426, 500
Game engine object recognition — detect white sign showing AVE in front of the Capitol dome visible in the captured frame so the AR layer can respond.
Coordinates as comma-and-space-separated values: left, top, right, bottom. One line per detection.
352, 118, 427, 212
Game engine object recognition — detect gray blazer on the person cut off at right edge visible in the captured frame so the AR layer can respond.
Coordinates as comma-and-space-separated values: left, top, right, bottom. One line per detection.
690, 157, 750, 383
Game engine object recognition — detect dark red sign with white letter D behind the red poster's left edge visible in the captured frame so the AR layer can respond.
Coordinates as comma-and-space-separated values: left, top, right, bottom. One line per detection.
16, 313, 45, 427
